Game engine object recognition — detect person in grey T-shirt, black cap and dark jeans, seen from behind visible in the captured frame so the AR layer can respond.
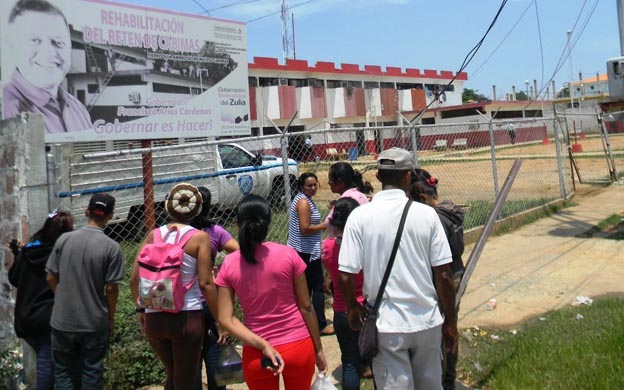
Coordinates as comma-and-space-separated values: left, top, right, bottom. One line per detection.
46, 194, 124, 389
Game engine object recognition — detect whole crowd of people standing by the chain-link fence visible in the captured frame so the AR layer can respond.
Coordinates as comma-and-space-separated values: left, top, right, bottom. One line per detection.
9, 148, 464, 390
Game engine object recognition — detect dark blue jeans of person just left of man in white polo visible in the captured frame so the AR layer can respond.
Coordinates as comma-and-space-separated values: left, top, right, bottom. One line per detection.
334, 311, 362, 390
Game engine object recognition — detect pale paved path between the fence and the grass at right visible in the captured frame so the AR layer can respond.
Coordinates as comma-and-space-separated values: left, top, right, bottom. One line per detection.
459, 185, 624, 328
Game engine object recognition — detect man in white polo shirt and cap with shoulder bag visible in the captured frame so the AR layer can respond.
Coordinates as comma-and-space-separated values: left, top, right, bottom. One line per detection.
338, 148, 457, 389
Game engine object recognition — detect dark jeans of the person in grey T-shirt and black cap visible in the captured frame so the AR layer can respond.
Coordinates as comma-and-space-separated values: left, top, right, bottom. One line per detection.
52, 329, 108, 390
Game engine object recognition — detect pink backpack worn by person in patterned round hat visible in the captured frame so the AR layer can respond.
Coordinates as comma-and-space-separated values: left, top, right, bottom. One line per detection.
138, 226, 199, 313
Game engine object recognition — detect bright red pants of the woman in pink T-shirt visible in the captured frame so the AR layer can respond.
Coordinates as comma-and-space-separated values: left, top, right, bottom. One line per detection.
243, 337, 315, 390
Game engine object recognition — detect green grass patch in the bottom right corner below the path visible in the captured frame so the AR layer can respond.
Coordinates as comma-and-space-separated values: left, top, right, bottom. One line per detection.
459, 296, 624, 389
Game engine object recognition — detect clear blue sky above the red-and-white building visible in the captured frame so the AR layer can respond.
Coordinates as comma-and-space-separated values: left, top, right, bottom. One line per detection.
117, 0, 621, 98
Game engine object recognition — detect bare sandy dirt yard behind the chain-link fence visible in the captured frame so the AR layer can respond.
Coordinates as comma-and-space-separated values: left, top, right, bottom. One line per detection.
306, 136, 624, 206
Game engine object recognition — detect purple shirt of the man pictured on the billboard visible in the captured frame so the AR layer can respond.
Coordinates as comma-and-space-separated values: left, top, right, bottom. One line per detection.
3, 70, 92, 134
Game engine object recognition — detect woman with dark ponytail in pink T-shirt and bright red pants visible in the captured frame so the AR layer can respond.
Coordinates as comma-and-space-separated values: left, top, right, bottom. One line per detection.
216, 195, 327, 390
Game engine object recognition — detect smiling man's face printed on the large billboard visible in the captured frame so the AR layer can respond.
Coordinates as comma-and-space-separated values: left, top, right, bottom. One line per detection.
7, 11, 71, 96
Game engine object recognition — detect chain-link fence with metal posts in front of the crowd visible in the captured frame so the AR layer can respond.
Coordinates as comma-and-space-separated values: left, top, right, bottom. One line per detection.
50, 116, 604, 250
